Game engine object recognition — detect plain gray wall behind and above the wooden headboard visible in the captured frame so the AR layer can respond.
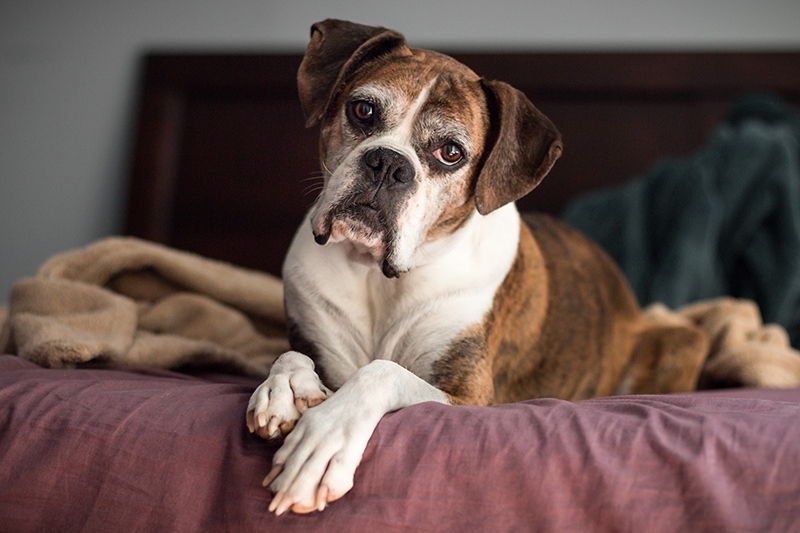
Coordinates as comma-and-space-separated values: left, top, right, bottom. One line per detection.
0, 0, 800, 305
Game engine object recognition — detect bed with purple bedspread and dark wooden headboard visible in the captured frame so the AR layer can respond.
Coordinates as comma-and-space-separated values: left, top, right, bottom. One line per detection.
0, 52, 800, 532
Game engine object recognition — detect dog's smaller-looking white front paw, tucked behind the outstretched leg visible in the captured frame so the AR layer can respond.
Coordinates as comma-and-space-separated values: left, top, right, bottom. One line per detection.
246, 352, 331, 439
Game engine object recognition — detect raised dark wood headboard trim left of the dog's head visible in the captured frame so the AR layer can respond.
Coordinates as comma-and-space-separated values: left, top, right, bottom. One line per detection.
125, 53, 302, 239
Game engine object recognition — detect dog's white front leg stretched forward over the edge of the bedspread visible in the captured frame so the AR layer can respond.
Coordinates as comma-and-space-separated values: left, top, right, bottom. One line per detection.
264, 360, 448, 515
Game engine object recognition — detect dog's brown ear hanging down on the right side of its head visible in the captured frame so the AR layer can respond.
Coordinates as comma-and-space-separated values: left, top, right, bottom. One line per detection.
475, 80, 563, 215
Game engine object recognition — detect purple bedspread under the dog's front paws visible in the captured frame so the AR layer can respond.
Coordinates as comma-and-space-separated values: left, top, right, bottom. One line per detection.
0, 356, 800, 533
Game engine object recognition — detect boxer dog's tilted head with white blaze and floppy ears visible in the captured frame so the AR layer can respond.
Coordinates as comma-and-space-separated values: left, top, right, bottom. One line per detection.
298, 20, 562, 277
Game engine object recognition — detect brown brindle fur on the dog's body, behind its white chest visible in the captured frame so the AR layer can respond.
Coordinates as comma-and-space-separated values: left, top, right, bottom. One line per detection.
434, 214, 706, 405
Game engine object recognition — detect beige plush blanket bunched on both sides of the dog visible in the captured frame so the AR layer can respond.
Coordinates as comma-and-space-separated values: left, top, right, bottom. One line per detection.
0, 238, 800, 387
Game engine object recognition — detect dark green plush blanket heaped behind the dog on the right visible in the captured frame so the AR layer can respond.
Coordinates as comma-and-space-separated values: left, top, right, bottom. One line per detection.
563, 95, 800, 346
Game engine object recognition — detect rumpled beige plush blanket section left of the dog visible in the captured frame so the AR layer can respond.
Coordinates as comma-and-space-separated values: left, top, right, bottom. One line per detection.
0, 238, 289, 376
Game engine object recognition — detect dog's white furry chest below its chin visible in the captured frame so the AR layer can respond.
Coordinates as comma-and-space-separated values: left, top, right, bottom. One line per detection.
284, 204, 519, 387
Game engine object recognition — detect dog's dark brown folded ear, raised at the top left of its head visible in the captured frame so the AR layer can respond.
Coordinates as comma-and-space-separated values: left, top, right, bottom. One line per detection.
297, 19, 407, 127
